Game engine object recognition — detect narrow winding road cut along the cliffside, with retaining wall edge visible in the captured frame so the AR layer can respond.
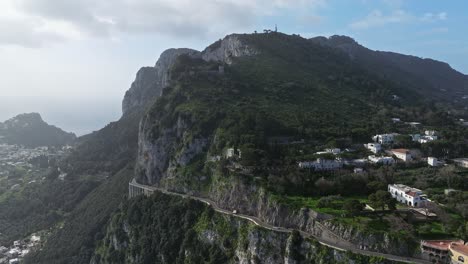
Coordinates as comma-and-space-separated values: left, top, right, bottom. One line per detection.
130, 179, 432, 264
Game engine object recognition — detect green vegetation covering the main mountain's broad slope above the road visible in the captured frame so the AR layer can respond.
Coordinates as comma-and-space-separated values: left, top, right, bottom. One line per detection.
137, 34, 468, 248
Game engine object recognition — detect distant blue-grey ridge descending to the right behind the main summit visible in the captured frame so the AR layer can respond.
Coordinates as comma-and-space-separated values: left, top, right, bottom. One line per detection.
310, 35, 468, 103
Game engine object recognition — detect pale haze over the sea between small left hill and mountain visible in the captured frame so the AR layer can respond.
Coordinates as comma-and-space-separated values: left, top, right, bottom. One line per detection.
0, 96, 121, 136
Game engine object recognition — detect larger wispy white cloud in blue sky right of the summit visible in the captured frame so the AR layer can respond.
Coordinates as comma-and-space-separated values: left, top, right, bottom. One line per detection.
350, 10, 413, 29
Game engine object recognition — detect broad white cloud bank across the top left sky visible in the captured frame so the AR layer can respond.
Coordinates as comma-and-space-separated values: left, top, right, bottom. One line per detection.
0, 0, 326, 46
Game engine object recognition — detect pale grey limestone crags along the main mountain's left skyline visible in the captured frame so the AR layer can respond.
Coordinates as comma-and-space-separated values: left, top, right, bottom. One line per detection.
122, 35, 258, 115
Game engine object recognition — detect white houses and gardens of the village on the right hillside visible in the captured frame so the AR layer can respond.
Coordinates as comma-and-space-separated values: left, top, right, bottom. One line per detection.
212, 118, 468, 263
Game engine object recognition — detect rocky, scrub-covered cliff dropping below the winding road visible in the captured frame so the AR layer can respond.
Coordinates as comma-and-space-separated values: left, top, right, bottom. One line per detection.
91, 194, 400, 264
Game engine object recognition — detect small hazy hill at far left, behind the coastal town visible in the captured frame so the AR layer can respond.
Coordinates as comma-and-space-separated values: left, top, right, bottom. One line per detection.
0, 113, 76, 147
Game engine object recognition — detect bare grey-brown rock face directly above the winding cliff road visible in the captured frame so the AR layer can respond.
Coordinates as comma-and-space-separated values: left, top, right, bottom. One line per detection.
206, 177, 414, 256
